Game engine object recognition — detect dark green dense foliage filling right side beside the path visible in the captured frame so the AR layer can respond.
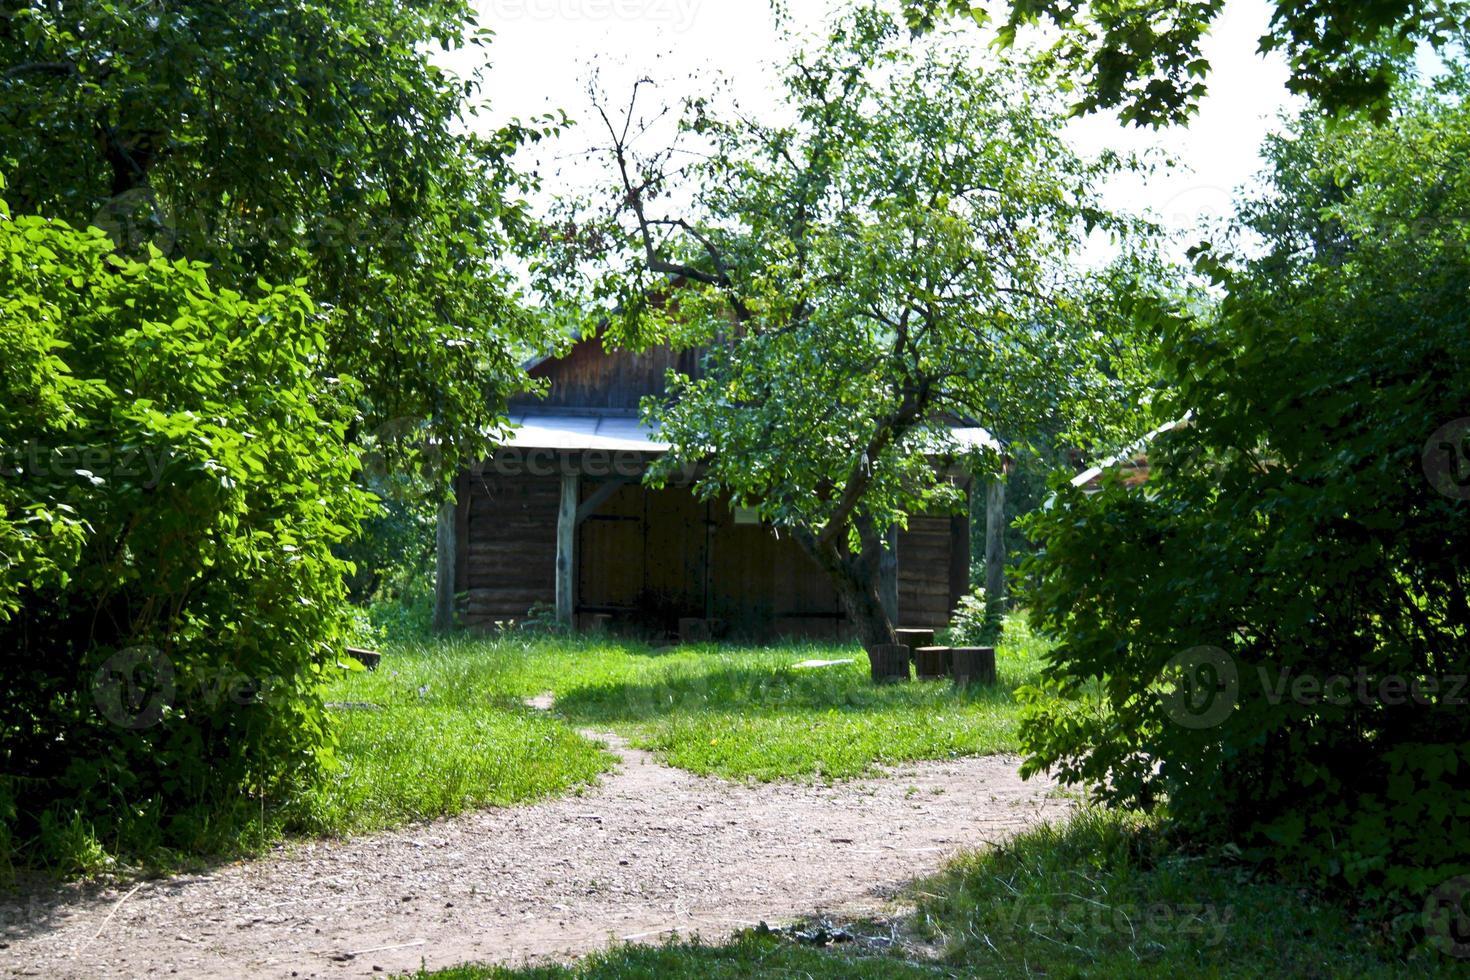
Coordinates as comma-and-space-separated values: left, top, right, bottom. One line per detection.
1026, 73, 1470, 927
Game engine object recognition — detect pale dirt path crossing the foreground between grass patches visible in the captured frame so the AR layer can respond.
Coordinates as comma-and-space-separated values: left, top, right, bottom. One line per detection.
0, 725, 1067, 979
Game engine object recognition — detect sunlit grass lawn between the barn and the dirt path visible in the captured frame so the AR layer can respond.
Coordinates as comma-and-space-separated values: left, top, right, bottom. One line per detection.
293, 621, 1045, 833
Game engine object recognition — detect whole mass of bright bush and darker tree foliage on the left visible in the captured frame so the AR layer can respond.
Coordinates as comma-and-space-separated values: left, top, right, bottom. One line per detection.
0, 0, 557, 871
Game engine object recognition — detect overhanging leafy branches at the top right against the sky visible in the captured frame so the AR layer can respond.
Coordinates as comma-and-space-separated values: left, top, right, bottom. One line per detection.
904, 0, 1470, 126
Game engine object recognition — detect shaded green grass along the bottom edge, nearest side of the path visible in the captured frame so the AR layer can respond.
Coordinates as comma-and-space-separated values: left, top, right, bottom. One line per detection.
396, 811, 1464, 980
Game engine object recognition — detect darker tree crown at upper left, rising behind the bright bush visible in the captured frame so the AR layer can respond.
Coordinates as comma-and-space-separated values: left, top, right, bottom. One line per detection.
0, 0, 550, 488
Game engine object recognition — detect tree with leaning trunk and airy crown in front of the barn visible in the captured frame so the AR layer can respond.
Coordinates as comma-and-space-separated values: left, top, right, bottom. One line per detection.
552, 7, 1158, 655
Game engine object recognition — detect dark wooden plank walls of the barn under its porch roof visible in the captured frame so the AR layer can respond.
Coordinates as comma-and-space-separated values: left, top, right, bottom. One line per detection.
457, 472, 969, 639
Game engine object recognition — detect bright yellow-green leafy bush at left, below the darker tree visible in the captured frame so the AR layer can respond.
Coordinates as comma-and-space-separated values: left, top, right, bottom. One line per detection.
0, 196, 370, 864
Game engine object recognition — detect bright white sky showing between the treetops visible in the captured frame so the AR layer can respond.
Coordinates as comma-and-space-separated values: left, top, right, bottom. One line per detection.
447, 0, 1291, 252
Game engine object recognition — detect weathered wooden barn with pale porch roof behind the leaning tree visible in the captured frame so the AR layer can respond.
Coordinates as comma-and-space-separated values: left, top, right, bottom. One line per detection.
440, 339, 989, 639
